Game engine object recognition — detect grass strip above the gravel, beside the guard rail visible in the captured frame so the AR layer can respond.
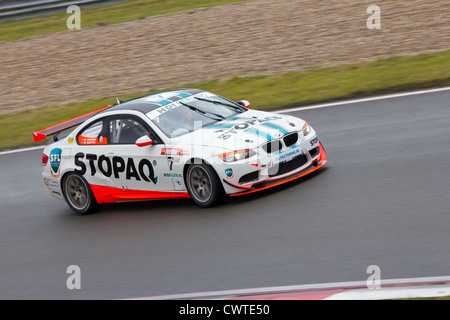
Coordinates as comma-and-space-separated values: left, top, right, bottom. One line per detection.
0, 0, 243, 43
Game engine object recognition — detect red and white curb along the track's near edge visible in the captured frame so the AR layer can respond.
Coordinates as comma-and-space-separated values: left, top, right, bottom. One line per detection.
125, 276, 450, 300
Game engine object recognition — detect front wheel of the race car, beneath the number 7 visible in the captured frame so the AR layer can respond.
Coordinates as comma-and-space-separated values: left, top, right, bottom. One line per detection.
185, 163, 226, 208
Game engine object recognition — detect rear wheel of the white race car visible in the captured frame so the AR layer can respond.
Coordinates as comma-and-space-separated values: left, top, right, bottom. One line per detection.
62, 172, 100, 215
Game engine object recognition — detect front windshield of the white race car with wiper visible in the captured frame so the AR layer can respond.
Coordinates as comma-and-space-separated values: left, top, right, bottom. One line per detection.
147, 93, 247, 138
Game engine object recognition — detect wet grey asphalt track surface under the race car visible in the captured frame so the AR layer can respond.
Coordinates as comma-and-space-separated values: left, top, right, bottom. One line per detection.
0, 91, 450, 299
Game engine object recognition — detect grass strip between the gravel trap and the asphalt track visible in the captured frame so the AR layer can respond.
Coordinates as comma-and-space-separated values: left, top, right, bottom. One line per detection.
0, 50, 450, 149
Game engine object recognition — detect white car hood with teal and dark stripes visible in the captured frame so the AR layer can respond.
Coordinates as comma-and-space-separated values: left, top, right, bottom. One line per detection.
174, 110, 305, 151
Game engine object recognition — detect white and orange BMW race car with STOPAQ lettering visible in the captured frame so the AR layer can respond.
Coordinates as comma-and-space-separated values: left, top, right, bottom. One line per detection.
33, 89, 327, 214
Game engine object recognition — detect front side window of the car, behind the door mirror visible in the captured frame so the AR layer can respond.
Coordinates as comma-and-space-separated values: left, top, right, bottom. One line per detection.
109, 117, 153, 144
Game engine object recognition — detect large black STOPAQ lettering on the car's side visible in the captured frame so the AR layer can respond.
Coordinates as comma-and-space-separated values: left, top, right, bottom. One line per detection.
75, 152, 158, 184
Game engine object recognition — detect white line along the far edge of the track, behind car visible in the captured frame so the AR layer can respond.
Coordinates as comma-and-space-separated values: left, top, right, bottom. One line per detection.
0, 87, 450, 155
